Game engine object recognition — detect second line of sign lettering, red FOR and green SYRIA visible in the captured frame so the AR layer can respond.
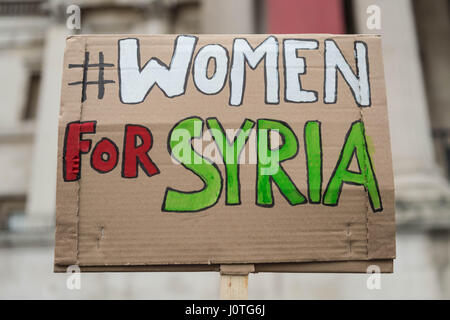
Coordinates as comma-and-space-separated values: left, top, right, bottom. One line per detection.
63, 116, 383, 212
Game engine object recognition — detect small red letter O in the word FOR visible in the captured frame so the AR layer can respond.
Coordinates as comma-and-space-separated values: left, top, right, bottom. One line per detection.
91, 138, 119, 173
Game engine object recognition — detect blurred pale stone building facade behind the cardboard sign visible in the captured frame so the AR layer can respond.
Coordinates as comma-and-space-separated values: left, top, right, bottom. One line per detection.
0, 0, 450, 299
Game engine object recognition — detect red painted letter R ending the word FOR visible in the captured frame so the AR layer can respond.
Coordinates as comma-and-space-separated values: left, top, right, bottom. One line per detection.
122, 124, 159, 178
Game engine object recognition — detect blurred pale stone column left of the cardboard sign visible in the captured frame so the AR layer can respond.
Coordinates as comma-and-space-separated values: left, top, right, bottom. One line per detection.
26, 24, 69, 227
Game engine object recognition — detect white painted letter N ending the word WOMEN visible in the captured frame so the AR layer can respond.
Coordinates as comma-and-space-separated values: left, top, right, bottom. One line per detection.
324, 39, 371, 107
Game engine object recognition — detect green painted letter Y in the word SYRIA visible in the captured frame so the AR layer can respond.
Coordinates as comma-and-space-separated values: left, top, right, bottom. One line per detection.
206, 118, 255, 205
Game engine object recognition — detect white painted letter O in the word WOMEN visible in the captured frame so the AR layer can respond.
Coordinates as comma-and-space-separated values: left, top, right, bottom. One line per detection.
193, 44, 228, 94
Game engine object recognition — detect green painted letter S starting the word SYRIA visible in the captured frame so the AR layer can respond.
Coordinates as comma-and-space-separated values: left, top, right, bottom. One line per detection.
162, 117, 222, 212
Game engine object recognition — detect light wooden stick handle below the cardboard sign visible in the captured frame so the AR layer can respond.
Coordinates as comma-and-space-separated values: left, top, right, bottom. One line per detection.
220, 264, 255, 300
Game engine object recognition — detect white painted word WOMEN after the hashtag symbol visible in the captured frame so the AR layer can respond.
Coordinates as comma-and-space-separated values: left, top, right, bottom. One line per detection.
118, 35, 371, 107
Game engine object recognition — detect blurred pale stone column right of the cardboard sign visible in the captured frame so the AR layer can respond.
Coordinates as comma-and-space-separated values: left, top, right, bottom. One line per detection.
353, 0, 449, 201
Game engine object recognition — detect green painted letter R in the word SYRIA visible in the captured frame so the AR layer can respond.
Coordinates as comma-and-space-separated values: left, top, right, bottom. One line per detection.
256, 119, 306, 207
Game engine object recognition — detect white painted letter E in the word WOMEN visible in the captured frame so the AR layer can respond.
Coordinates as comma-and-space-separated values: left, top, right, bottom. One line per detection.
283, 39, 319, 102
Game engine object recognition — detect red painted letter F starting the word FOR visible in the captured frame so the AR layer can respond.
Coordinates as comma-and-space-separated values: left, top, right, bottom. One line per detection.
63, 121, 96, 181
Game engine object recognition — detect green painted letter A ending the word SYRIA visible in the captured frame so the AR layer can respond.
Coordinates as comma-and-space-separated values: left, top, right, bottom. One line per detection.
323, 120, 383, 212
